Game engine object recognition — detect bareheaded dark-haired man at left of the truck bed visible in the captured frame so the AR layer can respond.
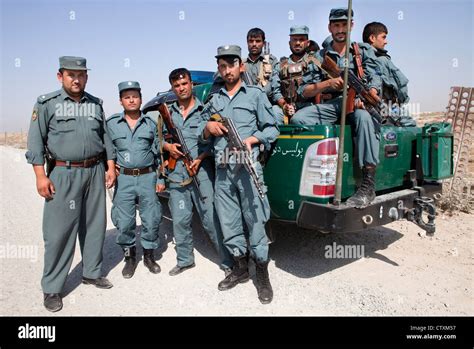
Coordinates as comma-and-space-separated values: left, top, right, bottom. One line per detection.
244, 28, 279, 100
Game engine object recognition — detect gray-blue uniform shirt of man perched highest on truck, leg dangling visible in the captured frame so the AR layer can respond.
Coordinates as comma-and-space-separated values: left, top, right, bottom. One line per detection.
298, 42, 382, 97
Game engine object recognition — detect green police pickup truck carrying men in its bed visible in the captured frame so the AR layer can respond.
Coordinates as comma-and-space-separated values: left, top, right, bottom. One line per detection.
144, 71, 453, 235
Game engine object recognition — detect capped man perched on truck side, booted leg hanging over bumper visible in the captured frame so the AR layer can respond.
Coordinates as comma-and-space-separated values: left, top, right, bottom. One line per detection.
291, 8, 381, 208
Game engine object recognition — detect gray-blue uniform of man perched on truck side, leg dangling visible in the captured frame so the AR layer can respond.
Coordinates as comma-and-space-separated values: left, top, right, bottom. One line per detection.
291, 44, 381, 167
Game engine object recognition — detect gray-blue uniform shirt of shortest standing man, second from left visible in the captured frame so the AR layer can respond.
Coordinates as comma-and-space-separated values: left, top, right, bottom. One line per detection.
107, 112, 160, 168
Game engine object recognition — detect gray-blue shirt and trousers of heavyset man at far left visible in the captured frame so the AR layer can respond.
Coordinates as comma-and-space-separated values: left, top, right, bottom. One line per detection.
26, 89, 115, 293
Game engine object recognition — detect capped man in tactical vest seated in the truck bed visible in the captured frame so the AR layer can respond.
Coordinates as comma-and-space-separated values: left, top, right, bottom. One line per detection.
272, 25, 317, 124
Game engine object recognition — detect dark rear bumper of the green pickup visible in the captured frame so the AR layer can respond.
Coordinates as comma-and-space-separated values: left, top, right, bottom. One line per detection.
296, 184, 441, 233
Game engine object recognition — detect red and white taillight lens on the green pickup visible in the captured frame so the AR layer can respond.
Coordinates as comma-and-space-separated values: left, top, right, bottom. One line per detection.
299, 138, 339, 198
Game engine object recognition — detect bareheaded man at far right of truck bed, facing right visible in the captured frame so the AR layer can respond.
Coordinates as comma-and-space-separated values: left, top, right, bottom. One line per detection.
360, 22, 416, 127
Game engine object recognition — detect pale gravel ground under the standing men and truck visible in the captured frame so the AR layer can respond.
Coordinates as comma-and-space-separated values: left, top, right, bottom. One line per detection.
0, 146, 474, 316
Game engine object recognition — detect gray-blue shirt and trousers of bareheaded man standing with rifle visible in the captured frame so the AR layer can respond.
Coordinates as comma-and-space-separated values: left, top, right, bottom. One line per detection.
164, 98, 233, 269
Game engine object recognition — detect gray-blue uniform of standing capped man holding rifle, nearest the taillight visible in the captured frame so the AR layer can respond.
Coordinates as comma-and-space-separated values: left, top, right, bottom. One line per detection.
202, 82, 279, 262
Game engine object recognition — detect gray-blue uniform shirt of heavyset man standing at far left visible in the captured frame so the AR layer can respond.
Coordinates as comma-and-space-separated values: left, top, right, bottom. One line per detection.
26, 89, 115, 165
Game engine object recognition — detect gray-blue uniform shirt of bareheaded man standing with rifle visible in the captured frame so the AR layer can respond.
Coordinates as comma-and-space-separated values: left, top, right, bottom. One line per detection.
163, 97, 212, 187
